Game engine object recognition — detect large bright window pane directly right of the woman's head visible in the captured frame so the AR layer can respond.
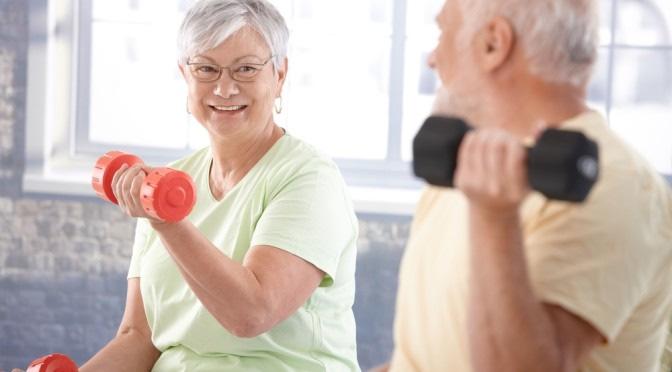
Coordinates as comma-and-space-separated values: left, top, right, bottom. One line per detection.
279, 0, 393, 159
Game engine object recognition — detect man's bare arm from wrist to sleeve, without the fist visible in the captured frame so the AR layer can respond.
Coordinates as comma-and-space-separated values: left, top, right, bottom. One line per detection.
468, 209, 603, 372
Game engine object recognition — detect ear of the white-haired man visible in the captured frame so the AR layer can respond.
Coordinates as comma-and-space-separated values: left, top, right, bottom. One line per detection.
476, 17, 516, 71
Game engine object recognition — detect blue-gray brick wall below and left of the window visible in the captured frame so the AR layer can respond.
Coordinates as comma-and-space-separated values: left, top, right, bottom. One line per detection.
0, 0, 409, 371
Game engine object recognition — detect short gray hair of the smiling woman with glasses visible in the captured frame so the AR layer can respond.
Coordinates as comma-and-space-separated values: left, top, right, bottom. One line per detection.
177, 0, 289, 69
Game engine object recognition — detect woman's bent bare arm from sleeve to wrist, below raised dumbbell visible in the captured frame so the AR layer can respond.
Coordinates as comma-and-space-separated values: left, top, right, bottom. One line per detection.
152, 221, 324, 337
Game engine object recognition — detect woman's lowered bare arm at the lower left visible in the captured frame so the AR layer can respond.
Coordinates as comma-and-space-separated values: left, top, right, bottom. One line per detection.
79, 278, 161, 372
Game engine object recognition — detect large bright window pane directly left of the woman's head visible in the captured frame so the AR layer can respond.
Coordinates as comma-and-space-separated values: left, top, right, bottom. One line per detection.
89, 19, 188, 148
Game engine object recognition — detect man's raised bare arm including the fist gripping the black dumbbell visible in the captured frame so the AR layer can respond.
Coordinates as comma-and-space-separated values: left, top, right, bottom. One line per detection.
456, 130, 603, 371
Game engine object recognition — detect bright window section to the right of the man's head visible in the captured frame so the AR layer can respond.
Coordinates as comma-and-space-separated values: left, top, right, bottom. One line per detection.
601, 0, 672, 175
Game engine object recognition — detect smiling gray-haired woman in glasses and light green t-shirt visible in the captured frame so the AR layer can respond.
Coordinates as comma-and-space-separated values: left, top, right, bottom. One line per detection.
81, 0, 359, 372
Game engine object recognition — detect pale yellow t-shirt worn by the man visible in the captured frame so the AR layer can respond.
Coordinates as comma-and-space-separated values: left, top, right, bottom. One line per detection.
391, 112, 672, 372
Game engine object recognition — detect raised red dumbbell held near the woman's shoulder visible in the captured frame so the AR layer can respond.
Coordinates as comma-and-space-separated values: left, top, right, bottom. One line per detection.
91, 151, 196, 222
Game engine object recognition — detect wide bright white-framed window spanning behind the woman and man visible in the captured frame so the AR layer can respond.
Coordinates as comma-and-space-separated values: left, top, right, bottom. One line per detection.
24, 0, 672, 211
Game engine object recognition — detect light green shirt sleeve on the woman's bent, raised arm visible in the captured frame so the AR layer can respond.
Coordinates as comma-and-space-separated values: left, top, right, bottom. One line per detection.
251, 162, 357, 287
